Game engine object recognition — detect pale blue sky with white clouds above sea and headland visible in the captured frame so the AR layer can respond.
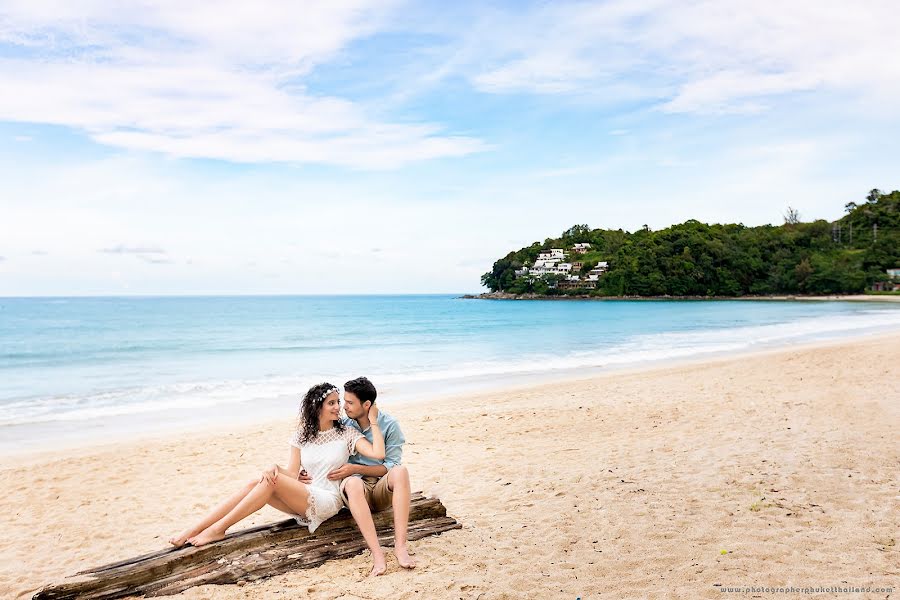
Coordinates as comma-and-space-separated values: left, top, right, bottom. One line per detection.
0, 0, 900, 296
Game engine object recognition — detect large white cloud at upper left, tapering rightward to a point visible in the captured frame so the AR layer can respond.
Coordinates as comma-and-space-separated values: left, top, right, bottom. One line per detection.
0, 1, 483, 168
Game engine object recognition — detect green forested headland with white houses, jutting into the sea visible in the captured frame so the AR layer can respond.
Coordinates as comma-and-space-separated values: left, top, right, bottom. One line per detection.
481, 190, 900, 297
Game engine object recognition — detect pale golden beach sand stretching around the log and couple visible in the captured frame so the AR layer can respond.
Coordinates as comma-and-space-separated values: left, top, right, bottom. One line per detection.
0, 334, 900, 600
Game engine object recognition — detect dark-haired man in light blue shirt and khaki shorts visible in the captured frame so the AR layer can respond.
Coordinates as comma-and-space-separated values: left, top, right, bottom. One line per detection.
301, 377, 416, 576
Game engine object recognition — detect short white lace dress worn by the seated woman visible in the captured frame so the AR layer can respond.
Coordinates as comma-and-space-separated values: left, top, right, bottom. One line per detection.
290, 427, 363, 533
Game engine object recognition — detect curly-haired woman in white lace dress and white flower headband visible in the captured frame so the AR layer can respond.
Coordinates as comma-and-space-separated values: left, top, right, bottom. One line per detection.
169, 383, 384, 547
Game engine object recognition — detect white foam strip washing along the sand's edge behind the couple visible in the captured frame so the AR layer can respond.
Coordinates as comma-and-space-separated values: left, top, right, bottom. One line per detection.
0, 310, 900, 426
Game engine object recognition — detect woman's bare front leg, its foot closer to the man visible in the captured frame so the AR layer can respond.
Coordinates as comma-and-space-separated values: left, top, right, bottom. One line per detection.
188, 475, 309, 546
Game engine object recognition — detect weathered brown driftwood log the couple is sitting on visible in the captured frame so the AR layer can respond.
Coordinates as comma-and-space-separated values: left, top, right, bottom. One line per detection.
34, 493, 462, 600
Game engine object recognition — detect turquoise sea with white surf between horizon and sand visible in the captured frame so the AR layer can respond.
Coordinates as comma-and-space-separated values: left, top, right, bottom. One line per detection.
0, 295, 900, 453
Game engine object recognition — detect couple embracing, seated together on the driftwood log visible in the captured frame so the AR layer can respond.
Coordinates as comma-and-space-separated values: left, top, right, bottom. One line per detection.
169, 377, 415, 575
